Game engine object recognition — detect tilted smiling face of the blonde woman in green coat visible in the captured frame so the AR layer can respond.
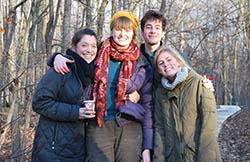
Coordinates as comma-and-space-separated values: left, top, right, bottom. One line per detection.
156, 51, 180, 81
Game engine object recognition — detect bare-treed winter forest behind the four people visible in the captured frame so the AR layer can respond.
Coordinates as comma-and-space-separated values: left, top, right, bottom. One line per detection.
0, 0, 250, 162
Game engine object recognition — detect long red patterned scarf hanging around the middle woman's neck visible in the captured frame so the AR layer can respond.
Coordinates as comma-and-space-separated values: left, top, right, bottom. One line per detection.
93, 38, 140, 127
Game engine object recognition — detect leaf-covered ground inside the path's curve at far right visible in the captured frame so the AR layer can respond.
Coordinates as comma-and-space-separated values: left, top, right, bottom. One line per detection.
218, 108, 250, 162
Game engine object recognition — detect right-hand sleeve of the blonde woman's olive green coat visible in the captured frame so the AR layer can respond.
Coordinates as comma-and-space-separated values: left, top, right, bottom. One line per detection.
198, 81, 221, 162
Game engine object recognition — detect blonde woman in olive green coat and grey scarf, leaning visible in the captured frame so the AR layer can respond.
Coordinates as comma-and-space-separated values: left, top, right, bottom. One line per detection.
153, 46, 221, 162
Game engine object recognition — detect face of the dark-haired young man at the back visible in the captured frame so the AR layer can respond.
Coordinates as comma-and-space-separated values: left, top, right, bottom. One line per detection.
142, 19, 164, 46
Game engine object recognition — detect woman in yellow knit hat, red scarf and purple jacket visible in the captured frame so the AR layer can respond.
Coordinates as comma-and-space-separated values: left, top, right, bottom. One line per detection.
83, 11, 153, 162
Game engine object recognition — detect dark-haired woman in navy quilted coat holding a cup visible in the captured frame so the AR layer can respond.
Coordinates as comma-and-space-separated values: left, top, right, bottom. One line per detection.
32, 29, 97, 162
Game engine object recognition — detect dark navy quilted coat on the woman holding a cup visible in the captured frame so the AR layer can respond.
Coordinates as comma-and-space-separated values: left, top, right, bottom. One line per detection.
32, 64, 90, 162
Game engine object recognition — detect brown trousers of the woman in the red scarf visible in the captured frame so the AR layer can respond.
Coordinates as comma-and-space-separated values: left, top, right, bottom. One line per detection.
86, 120, 142, 162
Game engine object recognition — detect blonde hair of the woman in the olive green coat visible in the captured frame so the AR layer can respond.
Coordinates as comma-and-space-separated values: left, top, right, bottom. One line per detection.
154, 45, 193, 70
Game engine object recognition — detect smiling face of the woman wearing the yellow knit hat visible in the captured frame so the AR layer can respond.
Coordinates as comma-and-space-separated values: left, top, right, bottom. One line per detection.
112, 28, 134, 48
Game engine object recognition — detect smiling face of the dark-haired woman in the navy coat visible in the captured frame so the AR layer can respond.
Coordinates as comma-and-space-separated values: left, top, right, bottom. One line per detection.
72, 35, 97, 63
